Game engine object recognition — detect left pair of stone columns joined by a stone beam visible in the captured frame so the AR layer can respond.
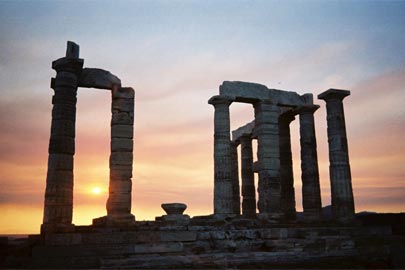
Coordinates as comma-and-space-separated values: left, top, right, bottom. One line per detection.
41, 42, 135, 232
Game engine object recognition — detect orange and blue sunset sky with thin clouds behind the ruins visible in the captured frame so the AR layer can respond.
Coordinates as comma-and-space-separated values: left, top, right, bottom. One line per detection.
0, 0, 405, 234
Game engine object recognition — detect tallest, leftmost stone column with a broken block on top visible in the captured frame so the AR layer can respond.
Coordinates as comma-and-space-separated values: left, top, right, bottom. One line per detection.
41, 41, 83, 232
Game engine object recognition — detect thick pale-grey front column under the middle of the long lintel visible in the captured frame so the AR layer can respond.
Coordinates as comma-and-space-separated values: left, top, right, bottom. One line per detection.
254, 101, 283, 222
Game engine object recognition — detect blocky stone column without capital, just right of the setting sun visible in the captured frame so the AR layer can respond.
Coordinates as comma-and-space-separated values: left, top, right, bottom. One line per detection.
107, 86, 135, 225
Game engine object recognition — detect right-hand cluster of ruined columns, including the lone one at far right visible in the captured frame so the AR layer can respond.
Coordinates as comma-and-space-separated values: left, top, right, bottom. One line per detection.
208, 82, 354, 223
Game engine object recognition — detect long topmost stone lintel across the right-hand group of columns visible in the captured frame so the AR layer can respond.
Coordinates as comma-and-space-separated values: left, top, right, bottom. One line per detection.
219, 81, 311, 106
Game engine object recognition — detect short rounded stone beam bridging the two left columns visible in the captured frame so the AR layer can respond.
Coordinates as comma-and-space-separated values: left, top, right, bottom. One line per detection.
78, 68, 121, 89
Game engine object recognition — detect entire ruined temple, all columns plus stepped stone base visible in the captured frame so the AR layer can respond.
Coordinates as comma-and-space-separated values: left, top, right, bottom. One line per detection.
22, 42, 391, 269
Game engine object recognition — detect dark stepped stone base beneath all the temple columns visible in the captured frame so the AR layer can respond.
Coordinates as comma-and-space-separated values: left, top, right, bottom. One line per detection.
32, 217, 391, 269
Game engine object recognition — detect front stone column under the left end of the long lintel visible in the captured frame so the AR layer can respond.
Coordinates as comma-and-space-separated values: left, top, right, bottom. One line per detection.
208, 96, 234, 216
